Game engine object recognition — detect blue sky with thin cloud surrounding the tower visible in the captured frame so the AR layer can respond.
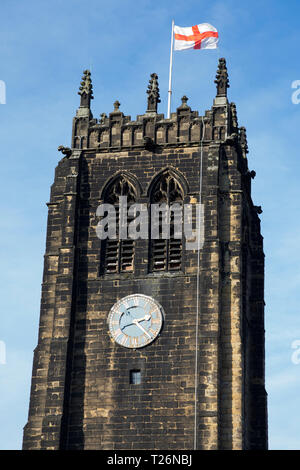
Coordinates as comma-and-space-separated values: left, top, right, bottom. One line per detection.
0, 0, 300, 449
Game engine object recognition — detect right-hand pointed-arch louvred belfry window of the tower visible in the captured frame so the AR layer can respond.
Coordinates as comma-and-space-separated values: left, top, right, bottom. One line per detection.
149, 170, 183, 272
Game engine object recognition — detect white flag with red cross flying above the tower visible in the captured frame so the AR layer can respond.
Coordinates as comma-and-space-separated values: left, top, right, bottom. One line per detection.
174, 23, 219, 51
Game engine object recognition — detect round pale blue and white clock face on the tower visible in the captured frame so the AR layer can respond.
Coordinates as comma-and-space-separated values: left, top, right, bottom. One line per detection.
107, 294, 164, 349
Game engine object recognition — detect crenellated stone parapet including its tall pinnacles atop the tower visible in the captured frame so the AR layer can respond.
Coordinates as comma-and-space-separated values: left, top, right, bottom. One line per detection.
72, 62, 252, 176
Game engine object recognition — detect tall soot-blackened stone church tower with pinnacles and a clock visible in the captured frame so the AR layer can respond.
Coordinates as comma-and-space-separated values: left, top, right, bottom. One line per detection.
23, 59, 267, 450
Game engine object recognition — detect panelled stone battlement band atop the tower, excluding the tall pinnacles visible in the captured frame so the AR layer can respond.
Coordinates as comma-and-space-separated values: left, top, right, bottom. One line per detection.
72, 97, 229, 151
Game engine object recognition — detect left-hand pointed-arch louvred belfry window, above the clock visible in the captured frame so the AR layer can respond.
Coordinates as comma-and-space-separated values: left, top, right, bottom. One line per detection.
101, 175, 136, 274
